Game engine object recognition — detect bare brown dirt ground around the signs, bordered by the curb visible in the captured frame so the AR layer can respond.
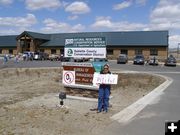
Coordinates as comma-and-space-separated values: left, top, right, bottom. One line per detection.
0, 68, 164, 135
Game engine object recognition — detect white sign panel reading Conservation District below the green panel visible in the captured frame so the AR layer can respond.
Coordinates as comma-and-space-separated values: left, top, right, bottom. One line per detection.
64, 47, 106, 58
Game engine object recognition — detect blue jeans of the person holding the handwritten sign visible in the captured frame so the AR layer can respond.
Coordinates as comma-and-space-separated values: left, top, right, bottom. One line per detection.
98, 88, 110, 112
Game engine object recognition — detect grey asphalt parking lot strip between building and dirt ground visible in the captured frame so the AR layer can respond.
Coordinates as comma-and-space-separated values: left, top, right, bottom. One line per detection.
0, 59, 180, 72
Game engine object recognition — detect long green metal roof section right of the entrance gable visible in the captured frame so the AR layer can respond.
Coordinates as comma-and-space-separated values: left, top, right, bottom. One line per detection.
41, 31, 168, 47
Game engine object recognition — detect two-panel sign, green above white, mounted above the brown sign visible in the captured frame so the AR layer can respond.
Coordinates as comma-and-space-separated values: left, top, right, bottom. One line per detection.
64, 37, 106, 58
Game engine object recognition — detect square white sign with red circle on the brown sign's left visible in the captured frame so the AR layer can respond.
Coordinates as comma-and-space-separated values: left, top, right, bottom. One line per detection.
63, 70, 75, 85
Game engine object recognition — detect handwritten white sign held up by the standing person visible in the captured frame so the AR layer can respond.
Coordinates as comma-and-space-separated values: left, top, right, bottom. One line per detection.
93, 73, 118, 84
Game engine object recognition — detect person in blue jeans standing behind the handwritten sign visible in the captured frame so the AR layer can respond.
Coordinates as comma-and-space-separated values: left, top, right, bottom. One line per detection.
97, 64, 111, 113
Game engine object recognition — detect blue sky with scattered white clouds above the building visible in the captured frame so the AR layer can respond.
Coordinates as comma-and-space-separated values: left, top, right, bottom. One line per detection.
0, 0, 180, 48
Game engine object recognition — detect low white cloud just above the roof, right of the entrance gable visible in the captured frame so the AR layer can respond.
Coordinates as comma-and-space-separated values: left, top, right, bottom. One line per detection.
41, 18, 85, 33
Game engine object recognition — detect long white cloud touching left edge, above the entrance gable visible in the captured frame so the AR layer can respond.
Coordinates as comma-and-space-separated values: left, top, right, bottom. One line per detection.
0, 14, 37, 27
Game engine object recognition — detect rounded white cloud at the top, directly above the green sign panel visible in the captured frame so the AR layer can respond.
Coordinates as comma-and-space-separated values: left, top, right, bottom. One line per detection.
65, 1, 90, 14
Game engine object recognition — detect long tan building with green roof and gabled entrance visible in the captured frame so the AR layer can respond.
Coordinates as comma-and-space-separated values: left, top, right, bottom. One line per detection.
0, 31, 168, 59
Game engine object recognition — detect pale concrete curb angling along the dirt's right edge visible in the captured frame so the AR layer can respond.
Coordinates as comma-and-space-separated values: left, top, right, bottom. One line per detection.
110, 74, 173, 123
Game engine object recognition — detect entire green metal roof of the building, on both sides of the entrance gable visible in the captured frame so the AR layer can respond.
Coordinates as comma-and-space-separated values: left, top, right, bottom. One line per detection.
0, 31, 168, 47
